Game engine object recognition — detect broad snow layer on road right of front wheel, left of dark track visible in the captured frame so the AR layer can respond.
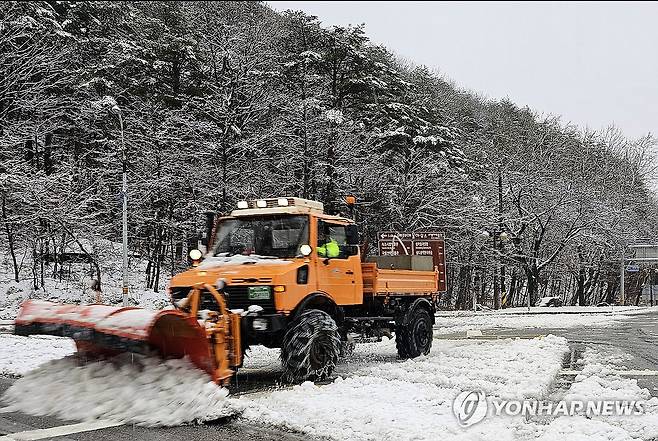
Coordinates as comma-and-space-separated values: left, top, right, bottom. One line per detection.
239, 336, 568, 440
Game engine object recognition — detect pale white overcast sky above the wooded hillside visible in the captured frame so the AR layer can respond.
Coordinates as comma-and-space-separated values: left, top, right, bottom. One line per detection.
268, 1, 658, 141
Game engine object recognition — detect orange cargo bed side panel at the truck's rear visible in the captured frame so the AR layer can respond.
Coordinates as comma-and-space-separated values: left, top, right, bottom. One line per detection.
361, 263, 439, 295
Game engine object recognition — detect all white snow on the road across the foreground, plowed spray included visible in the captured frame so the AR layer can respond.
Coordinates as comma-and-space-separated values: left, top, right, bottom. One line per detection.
0, 335, 658, 441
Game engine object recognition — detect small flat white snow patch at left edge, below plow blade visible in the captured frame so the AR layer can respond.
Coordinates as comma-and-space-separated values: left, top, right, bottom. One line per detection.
0, 334, 76, 376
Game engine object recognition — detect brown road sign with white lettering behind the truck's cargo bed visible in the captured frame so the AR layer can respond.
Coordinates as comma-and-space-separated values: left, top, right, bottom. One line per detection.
377, 231, 447, 292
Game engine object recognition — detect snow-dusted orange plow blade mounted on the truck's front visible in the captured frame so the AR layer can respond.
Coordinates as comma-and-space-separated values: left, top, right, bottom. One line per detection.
14, 300, 224, 383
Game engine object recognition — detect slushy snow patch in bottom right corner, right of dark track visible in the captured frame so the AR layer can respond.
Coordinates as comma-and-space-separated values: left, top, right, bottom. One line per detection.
540, 349, 658, 441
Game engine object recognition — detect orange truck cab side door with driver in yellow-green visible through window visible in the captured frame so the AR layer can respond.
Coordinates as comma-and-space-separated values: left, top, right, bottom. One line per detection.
315, 219, 363, 305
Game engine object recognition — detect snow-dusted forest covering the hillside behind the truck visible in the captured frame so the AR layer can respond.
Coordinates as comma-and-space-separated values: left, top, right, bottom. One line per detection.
0, 1, 658, 309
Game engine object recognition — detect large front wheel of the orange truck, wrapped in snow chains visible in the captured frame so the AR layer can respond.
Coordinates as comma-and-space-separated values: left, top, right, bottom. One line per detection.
281, 309, 340, 382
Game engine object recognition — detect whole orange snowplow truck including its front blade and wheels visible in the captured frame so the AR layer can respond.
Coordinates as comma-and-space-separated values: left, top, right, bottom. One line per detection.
15, 197, 439, 385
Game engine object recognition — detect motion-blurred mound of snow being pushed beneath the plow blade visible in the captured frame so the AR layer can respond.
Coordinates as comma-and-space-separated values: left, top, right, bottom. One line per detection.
2, 354, 239, 427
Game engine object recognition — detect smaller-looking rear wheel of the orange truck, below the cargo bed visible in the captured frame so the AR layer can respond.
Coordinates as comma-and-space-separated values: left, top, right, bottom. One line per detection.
395, 308, 433, 358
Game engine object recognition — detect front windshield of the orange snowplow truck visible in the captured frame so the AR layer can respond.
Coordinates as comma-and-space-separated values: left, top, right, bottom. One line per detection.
214, 215, 308, 257
